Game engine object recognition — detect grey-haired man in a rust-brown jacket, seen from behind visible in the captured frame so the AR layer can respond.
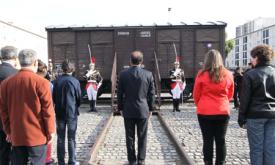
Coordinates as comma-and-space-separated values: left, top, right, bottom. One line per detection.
0, 49, 55, 165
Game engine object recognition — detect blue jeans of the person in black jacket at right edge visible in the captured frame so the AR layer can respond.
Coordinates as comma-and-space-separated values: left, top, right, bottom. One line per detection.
247, 119, 275, 165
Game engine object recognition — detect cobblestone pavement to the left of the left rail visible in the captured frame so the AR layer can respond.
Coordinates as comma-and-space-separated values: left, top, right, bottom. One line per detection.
52, 104, 111, 163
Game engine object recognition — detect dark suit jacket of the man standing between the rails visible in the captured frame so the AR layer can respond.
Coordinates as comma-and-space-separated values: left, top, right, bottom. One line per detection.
117, 66, 155, 119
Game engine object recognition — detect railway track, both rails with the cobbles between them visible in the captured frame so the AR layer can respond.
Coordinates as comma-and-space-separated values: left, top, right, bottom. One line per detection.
83, 112, 195, 165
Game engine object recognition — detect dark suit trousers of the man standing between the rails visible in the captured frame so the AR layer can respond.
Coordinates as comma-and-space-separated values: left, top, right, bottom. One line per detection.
124, 118, 148, 162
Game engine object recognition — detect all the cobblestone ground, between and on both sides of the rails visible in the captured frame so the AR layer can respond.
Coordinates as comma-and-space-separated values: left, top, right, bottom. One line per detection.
50, 103, 252, 165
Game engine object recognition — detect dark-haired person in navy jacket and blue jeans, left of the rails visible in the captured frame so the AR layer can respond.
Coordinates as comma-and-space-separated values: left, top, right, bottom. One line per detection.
53, 60, 81, 165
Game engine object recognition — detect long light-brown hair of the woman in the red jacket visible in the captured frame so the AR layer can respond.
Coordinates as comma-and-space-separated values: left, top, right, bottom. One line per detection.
201, 49, 225, 83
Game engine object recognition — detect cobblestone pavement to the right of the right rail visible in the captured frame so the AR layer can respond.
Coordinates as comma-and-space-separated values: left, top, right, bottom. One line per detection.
161, 103, 250, 165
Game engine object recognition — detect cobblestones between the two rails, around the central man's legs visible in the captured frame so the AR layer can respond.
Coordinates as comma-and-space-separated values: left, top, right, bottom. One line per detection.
97, 116, 179, 165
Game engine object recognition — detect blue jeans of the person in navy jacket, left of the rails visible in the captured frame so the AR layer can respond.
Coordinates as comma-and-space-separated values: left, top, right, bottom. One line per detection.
56, 118, 77, 165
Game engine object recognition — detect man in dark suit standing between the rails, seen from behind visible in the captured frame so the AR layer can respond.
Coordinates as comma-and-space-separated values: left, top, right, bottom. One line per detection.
118, 51, 155, 165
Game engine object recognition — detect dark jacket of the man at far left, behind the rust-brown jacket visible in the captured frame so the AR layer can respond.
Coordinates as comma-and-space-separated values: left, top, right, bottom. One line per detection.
0, 62, 17, 130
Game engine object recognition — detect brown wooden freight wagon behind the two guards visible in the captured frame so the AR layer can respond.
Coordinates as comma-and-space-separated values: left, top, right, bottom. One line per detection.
46, 23, 226, 102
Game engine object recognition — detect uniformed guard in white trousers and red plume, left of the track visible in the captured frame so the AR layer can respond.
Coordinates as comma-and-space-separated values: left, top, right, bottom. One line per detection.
84, 57, 103, 112
